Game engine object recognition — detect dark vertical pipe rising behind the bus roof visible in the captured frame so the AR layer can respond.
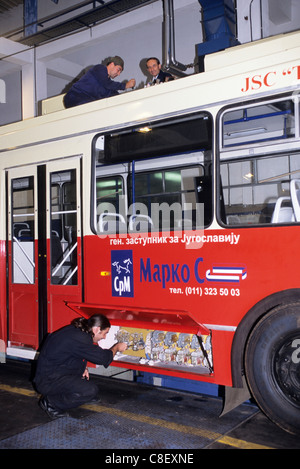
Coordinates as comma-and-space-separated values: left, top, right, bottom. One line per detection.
163, 0, 188, 77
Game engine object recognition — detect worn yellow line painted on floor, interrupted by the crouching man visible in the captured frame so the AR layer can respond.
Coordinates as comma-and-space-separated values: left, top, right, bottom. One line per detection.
0, 384, 272, 449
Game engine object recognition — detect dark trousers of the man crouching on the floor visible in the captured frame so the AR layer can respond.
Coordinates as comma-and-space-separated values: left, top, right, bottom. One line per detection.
39, 375, 99, 411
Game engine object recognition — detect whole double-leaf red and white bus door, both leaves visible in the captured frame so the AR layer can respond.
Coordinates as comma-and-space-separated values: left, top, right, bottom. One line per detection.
7, 158, 82, 350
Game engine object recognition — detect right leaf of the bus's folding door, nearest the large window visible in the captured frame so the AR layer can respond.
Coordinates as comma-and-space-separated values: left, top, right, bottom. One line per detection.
46, 158, 82, 332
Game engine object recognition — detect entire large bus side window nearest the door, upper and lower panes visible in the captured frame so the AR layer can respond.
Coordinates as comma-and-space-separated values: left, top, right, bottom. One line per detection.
91, 112, 213, 234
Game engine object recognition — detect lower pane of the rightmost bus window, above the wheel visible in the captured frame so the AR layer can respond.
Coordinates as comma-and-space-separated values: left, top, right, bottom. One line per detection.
220, 153, 300, 225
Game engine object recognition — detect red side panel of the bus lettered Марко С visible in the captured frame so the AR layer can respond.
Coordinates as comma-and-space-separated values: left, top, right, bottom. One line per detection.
77, 226, 300, 385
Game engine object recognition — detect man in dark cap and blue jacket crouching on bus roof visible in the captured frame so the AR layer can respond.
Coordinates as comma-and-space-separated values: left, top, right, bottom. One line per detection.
64, 55, 135, 108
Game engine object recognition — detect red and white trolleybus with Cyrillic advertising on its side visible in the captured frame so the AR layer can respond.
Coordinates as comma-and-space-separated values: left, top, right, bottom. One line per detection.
0, 32, 300, 433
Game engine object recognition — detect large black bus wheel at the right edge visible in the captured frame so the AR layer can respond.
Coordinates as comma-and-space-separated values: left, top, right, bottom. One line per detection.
245, 303, 300, 434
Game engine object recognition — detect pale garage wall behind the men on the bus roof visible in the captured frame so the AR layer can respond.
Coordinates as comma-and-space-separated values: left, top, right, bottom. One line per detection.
0, 0, 300, 125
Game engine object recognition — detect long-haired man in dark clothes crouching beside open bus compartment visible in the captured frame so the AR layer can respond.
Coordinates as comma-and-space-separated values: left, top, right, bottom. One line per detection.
34, 314, 127, 419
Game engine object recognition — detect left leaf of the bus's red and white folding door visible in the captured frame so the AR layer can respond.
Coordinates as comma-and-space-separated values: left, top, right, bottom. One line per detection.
8, 166, 39, 348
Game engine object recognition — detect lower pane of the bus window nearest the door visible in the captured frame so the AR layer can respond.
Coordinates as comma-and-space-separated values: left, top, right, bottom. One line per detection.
96, 164, 212, 234
